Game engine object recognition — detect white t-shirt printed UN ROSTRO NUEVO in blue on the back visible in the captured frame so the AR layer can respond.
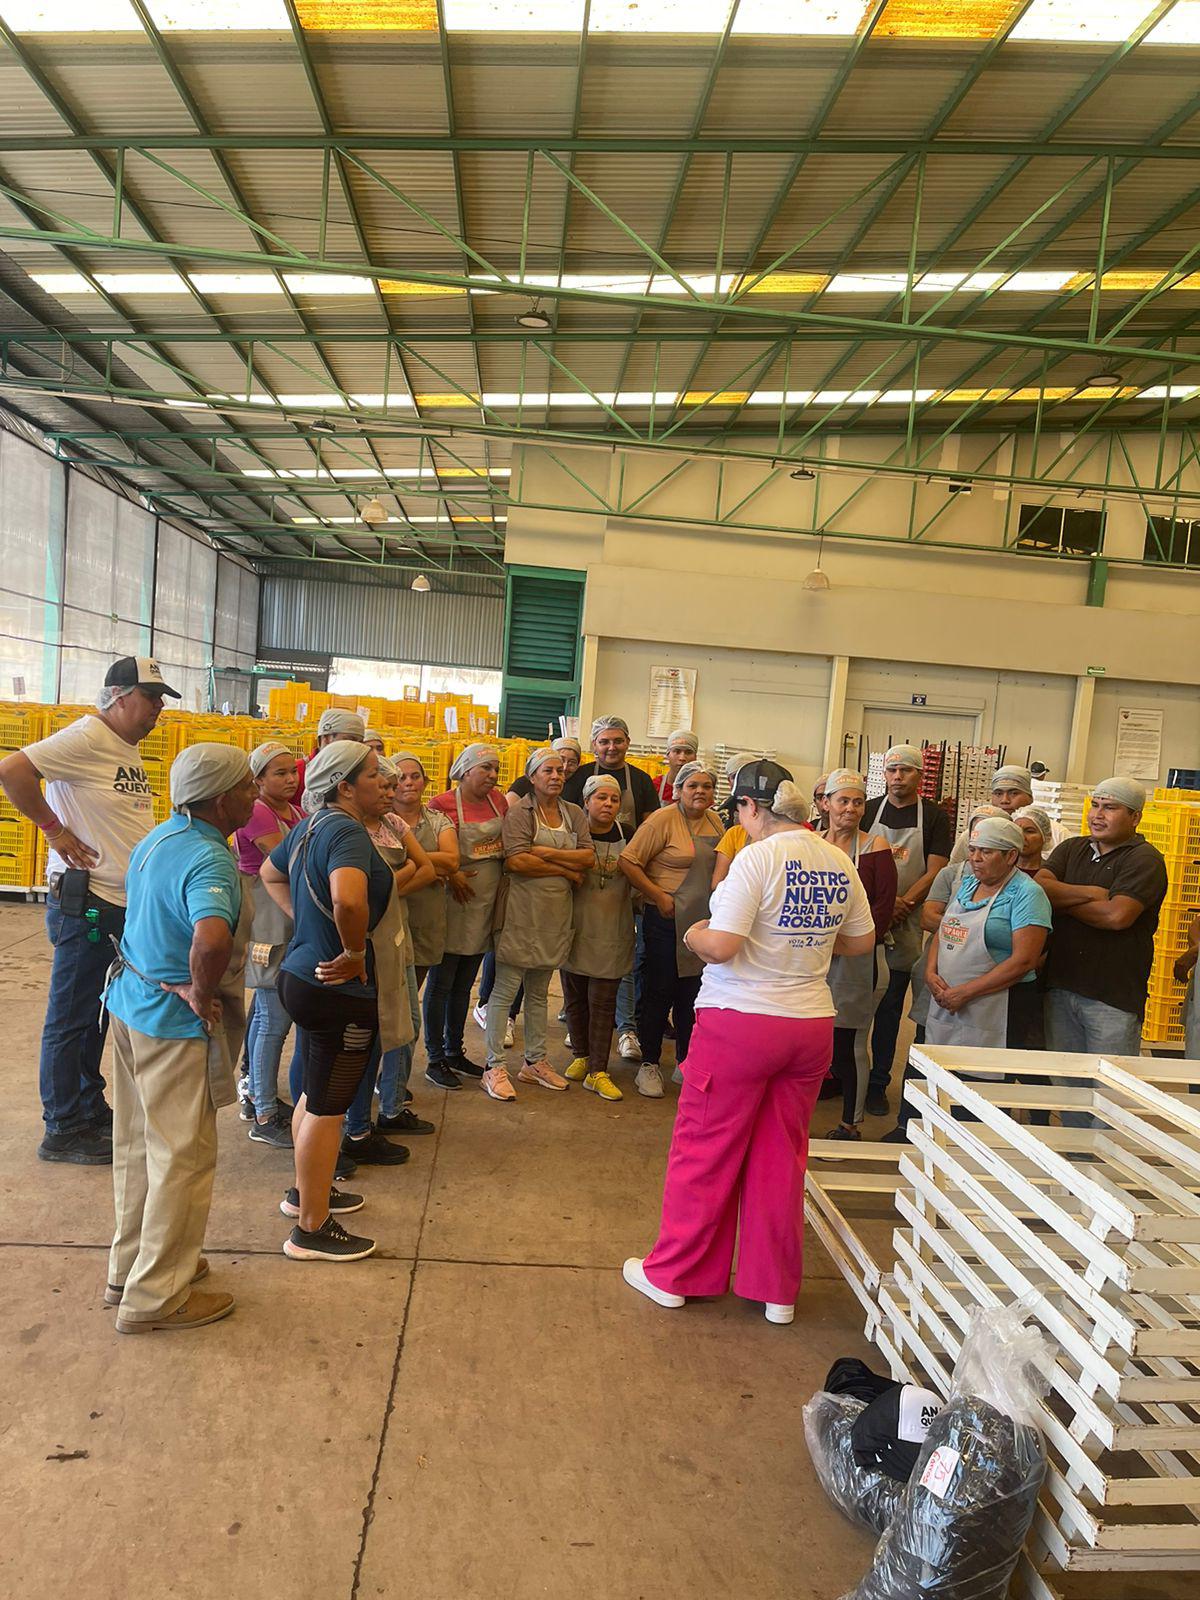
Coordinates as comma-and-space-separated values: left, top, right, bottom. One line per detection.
696, 829, 875, 1018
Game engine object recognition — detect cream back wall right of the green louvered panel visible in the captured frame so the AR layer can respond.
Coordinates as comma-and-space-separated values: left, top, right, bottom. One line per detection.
507, 434, 1200, 790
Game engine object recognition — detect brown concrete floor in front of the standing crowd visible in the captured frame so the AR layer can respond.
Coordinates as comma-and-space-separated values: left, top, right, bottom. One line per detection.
0, 901, 908, 1600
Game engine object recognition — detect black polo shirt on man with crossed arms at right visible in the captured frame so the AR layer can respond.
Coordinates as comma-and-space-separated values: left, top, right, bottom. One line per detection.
1046, 834, 1166, 1016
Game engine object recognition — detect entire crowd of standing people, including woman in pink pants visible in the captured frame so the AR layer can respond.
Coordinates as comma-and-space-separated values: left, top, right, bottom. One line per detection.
0, 658, 1200, 1333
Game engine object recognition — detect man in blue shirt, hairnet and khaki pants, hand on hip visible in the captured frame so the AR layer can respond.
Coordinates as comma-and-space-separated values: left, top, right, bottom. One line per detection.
104, 744, 254, 1333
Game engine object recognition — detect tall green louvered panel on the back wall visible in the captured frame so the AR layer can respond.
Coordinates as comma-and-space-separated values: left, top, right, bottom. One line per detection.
501, 566, 587, 739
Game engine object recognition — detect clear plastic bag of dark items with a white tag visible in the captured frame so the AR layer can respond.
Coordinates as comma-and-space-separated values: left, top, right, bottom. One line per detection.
846, 1309, 1048, 1600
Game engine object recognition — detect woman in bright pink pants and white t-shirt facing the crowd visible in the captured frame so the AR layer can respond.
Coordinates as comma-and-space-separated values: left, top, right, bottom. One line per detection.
624, 762, 875, 1322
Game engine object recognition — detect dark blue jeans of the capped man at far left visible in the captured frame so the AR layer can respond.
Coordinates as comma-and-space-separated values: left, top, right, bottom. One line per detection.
38, 898, 125, 1133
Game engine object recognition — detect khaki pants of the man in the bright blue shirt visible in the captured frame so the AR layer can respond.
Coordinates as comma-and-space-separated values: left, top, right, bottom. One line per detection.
109, 1016, 216, 1322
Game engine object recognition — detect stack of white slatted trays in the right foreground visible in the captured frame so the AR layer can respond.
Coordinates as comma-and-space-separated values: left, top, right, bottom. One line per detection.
808, 1048, 1200, 1587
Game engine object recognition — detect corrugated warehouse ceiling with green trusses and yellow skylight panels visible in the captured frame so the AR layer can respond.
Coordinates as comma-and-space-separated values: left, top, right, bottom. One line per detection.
0, 0, 1200, 573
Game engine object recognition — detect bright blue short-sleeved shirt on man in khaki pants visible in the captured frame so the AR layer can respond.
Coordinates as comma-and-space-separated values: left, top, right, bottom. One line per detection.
109, 816, 242, 1038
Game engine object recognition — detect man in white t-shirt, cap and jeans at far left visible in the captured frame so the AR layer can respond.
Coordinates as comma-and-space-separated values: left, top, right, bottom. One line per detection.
0, 656, 179, 1166
